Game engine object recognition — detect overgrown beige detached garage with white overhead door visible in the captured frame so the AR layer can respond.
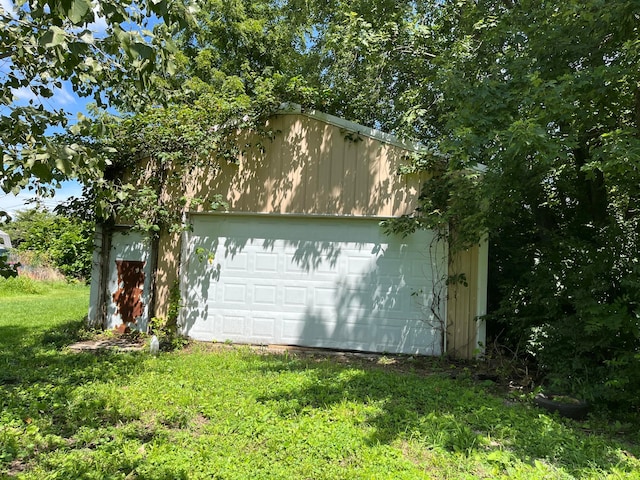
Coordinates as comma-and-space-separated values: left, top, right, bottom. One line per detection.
90, 109, 487, 357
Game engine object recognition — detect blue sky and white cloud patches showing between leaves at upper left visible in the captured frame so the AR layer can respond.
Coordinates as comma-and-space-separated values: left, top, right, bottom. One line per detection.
0, 0, 106, 215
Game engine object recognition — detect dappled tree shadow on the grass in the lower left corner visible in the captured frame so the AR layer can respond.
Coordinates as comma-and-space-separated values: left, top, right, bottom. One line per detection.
0, 312, 188, 479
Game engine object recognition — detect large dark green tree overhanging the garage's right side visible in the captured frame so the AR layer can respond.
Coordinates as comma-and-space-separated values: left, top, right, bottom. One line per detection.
304, 0, 640, 405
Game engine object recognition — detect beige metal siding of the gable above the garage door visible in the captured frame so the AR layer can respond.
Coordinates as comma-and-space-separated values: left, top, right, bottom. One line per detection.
178, 115, 421, 217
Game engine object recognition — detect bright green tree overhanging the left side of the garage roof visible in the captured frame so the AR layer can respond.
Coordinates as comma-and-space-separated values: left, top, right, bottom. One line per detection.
68, 0, 328, 234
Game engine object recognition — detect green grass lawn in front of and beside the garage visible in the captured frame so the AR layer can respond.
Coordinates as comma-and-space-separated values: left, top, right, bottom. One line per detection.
0, 284, 640, 480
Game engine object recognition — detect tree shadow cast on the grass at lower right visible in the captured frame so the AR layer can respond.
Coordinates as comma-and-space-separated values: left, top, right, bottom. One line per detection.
258, 355, 638, 476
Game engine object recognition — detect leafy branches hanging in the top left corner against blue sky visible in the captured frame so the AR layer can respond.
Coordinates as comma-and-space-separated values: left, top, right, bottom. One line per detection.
0, 0, 192, 205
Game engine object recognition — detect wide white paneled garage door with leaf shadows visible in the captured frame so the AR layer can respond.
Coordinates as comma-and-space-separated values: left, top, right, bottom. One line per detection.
181, 215, 446, 355
